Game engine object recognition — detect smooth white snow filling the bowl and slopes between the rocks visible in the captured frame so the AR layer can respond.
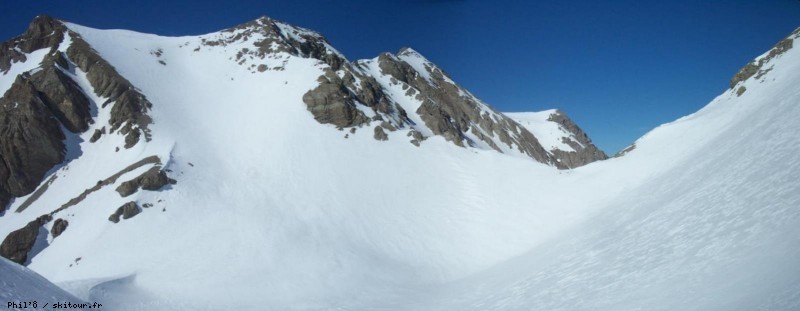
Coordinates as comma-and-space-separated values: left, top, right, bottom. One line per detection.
0, 20, 800, 310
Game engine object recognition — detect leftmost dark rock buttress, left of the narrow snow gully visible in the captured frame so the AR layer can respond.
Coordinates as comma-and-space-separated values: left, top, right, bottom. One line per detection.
0, 16, 70, 210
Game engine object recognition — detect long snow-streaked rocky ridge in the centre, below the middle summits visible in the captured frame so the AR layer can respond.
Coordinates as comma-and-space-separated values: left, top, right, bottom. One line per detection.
209, 17, 604, 169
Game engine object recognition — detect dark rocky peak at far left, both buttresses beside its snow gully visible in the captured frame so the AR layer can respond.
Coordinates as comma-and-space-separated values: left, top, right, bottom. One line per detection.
0, 16, 158, 210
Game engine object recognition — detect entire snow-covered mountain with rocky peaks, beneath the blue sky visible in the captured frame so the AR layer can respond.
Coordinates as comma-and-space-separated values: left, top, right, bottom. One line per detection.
0, 17, 800, 310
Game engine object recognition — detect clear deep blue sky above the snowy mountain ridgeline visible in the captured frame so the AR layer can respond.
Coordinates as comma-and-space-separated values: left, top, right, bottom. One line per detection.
0, 0, 800, 154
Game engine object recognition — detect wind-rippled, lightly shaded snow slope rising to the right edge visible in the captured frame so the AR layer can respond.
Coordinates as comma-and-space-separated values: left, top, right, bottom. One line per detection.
412, 30, 800, 310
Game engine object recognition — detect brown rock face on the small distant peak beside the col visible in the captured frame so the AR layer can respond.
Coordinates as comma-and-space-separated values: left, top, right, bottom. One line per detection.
547, 110, 608, 168
